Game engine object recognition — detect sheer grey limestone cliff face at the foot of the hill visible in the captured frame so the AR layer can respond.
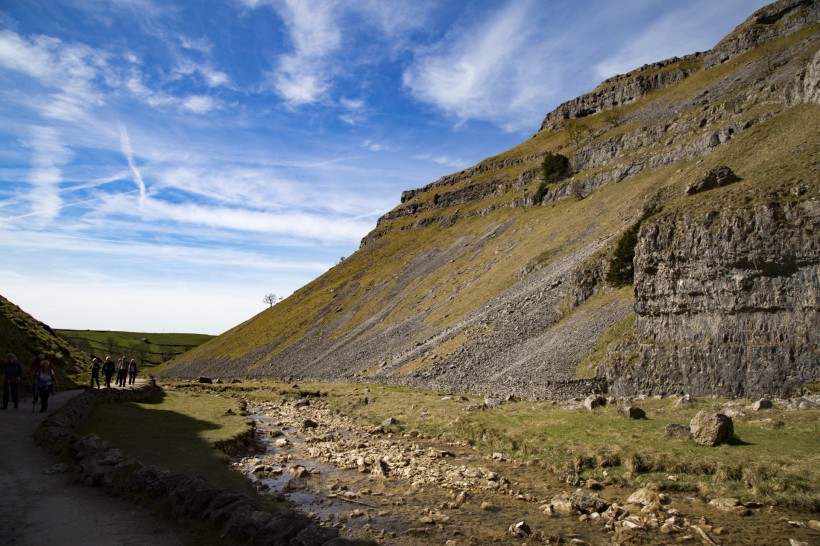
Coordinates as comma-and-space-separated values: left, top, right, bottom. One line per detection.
607, 201, 820, 397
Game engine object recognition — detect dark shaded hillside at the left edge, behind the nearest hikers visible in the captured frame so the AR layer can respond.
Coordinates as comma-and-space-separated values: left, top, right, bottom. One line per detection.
0, 296, 90, 388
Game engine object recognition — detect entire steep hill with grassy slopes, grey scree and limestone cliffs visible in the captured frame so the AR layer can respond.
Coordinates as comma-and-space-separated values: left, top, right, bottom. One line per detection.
162, 0, 820, 397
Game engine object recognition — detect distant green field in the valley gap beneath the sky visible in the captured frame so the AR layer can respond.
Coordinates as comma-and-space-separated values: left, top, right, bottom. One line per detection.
55, 330, 214, 368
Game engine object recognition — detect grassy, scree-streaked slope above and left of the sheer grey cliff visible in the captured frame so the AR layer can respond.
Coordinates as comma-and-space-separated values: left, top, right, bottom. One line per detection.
157, 5, 820, 396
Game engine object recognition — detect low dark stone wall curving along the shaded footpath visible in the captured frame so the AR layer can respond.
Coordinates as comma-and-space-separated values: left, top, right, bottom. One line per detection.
35, 385, 349, 546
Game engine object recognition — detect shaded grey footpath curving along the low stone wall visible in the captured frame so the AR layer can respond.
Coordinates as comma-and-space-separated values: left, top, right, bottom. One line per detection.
0, 391, 185, 546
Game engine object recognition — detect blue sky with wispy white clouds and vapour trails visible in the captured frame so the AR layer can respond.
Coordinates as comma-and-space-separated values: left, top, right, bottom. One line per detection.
0, 0, 765, 334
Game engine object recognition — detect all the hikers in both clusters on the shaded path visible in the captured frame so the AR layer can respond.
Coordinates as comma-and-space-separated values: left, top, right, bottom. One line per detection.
2, 353, 138, 413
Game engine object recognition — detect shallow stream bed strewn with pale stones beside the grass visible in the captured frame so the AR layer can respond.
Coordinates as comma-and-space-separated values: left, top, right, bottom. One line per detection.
233, 388, 820, 546
